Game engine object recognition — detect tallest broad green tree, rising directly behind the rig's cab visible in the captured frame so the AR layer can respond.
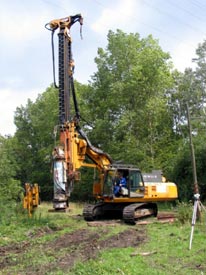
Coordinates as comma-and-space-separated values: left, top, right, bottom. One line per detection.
85, 30, 176, 171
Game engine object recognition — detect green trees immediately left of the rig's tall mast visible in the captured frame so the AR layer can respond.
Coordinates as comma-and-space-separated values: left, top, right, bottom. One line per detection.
14, 87, 58, 199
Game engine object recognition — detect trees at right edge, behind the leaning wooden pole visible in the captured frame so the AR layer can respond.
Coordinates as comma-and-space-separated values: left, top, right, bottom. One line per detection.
170, 41, 206, 200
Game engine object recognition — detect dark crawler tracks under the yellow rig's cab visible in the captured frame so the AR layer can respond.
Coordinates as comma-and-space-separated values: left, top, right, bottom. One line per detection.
83, 202, 157, 225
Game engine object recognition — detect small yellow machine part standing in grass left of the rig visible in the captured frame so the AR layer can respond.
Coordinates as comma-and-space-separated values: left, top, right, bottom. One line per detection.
23, 183, 40, 217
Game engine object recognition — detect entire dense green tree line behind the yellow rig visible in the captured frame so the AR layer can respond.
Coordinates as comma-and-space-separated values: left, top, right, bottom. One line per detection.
0, 30, 206, 206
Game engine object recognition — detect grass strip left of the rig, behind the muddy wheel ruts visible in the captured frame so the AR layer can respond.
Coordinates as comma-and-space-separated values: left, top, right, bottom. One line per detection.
0, 203, 84, 245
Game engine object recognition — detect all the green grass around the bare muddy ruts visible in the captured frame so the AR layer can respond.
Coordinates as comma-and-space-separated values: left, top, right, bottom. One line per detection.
0, 204, 206, 275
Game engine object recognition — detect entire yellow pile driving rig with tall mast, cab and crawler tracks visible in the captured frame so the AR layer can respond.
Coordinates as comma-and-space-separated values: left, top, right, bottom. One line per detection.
46, 14, 177, 224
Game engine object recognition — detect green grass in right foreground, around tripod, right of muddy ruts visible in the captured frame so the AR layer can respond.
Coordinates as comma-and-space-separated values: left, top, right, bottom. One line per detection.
68, 206, 206, 275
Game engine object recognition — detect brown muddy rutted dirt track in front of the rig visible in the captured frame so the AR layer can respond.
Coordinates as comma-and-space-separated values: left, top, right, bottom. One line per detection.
0, 221, 146, 275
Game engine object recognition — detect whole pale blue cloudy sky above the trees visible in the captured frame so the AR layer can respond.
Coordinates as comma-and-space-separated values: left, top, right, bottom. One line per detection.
0, 0, 206, 135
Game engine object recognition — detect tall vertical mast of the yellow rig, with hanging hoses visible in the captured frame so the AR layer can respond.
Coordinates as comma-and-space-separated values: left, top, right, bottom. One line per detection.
46, 14, 83, 210
